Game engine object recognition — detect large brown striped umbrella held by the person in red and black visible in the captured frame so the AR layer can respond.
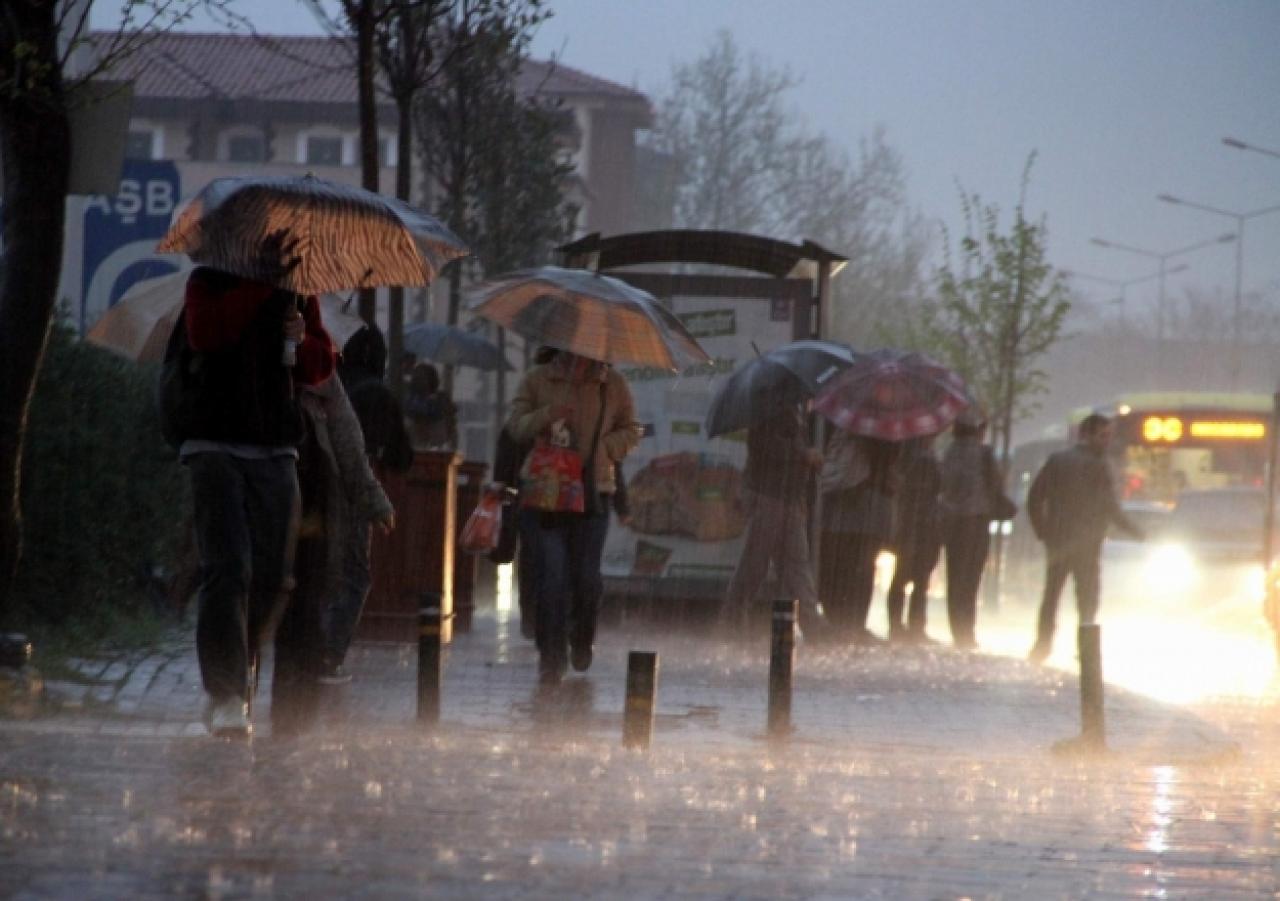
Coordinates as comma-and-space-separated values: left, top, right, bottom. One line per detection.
156, 175, 468, 294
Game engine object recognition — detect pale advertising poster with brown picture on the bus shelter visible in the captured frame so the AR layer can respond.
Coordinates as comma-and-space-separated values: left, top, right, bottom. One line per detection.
603, 296, 792, 590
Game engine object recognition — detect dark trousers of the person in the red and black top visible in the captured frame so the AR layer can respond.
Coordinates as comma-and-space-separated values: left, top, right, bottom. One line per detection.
186, 453, 298, 701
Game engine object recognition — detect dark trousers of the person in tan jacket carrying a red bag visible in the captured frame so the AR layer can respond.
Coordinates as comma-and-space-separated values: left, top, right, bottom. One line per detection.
521, 503, 609, 671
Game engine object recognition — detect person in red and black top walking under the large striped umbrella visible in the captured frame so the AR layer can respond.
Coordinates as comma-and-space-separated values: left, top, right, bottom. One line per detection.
172, 267, 334, 736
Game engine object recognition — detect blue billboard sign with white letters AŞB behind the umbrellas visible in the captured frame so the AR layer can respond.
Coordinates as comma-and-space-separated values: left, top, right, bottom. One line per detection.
79, 160, 184, 334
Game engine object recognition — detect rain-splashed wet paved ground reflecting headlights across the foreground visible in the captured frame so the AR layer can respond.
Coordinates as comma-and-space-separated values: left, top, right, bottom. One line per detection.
0, 598, 1280, 898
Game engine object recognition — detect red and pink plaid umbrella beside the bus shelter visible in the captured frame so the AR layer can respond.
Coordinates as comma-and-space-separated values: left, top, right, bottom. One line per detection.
814, 349, 970, 442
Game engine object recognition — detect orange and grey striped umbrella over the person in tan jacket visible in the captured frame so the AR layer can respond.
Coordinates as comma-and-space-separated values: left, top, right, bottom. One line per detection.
471, 266, 710, 370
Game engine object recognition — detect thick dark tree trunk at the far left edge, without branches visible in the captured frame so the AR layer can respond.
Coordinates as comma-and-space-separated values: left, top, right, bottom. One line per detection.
0, 10, 72, 623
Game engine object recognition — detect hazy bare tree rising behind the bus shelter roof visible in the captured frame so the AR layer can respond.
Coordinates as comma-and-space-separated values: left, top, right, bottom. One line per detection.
644, 32, 929, 344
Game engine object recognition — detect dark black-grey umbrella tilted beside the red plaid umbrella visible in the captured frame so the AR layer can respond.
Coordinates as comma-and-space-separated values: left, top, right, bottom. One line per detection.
707, 340, 856, 438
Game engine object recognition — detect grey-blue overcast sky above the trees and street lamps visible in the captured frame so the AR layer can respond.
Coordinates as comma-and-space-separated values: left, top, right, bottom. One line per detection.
95, 0, 1280, 323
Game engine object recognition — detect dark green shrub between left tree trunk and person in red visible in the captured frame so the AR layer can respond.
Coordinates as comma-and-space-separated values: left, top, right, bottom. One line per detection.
17, 325, 189, 639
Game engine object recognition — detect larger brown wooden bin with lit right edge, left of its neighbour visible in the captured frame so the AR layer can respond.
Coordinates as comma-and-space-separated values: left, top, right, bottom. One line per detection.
356, 451, 460, 642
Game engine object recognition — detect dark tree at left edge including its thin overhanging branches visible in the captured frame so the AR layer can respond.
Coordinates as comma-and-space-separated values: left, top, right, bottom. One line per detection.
0, 0, 225, 621
